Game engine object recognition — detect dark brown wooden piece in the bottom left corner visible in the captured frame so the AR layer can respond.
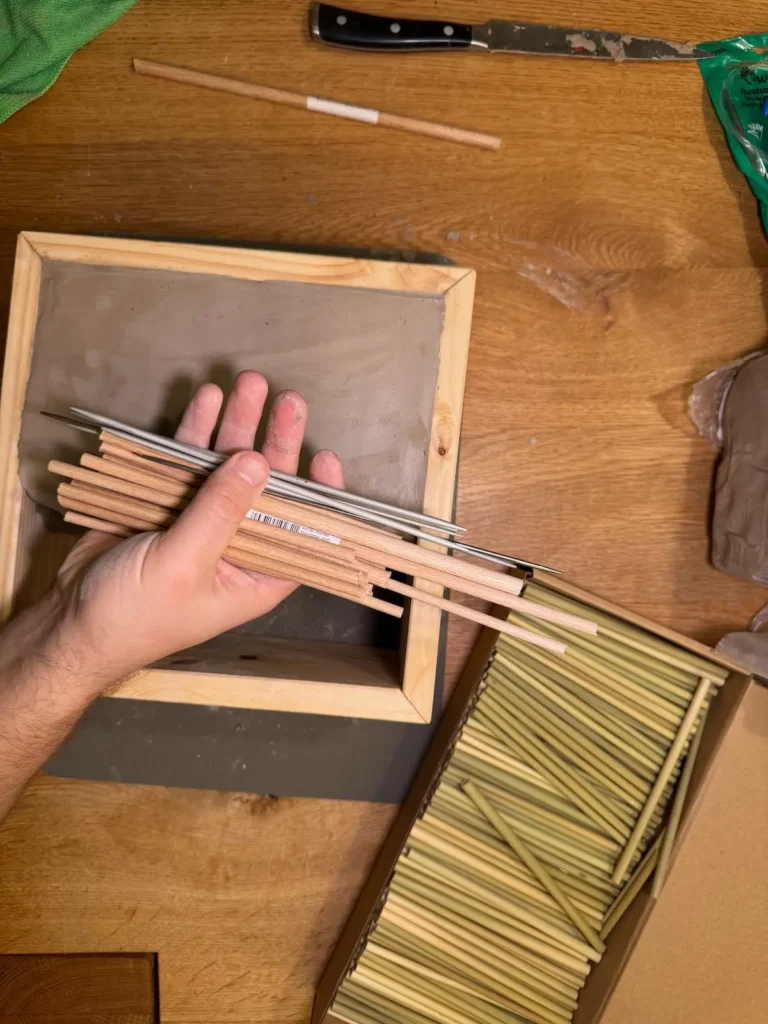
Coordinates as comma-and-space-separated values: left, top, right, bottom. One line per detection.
0, 953, 157, 1024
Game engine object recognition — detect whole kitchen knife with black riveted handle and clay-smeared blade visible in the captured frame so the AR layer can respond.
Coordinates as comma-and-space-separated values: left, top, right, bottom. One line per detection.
309, 3, 712, 60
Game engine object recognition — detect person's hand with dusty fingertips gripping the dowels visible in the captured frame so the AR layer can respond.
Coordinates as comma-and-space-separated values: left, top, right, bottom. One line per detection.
10, 371, 343, 692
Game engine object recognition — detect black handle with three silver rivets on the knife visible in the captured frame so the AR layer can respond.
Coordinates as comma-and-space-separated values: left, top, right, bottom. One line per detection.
309, 3, 472, 52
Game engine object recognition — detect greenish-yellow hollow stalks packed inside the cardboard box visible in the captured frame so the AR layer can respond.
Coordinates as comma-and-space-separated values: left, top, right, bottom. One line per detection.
332, 584, 727, 1024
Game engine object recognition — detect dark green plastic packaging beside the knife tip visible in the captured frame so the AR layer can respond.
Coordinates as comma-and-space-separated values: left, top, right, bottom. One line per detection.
698, 33, 768, 232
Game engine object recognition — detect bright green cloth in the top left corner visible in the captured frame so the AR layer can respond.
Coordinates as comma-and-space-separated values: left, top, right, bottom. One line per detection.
0, 0, 136, 122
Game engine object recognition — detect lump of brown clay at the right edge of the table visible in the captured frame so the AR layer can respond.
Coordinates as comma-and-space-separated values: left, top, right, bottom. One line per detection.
712, 353, 768, 587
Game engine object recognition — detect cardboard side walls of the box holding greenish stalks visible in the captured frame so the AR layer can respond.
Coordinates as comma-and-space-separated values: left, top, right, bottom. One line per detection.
310, 575, 751, 1024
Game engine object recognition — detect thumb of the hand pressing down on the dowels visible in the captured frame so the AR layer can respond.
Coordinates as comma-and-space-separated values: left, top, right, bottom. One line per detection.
160, 452, 269, 572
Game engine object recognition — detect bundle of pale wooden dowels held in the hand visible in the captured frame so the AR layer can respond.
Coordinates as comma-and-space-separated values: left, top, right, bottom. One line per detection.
48, 430, 597, 653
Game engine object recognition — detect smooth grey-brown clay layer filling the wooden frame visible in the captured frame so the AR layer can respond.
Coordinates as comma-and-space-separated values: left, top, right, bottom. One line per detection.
19, 262, 443, 507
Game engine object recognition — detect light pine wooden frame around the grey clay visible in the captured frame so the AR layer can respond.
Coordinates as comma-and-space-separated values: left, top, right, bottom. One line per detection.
0, 231, 475, 723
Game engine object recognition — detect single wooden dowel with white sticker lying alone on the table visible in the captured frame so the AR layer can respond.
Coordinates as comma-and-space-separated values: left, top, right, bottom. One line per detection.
133, 57, 502, 150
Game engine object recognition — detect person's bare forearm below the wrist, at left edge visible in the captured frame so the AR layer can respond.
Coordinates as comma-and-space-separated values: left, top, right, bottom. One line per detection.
0, 595, 100, 821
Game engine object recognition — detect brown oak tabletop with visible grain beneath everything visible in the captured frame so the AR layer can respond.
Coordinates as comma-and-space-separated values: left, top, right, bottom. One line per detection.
0, 0, 768, 1024
